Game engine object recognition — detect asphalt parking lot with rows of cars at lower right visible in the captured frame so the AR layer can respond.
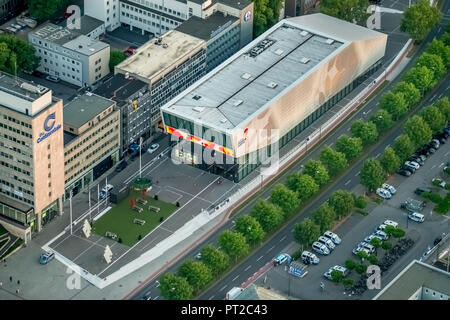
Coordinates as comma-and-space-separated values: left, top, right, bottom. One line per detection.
256, 134, 450, 300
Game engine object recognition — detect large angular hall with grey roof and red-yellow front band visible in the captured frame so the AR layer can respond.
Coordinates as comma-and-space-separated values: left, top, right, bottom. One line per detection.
161, 14, 387, 181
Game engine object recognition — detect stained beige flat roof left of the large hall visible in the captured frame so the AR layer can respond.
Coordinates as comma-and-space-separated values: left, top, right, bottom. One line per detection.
115, 30, 206, 83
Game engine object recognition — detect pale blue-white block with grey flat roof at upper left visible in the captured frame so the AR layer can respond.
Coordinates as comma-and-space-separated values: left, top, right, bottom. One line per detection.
28, 22, 110, 87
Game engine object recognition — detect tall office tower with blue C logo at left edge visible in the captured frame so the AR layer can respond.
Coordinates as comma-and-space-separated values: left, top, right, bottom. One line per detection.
0, 73, 64, 242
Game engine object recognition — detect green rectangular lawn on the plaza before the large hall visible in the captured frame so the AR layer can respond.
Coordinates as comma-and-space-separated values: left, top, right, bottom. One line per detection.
92, 192, 177, 247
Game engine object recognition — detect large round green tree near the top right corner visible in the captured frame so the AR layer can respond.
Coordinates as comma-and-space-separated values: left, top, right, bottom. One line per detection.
400, 0, 442, 42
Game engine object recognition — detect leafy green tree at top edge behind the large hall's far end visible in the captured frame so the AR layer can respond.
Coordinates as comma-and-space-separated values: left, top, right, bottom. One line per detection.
320, 0, 369, 24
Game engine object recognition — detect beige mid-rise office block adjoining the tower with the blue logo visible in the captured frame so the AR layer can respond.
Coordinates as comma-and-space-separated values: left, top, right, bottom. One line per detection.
63, 92, 120, 199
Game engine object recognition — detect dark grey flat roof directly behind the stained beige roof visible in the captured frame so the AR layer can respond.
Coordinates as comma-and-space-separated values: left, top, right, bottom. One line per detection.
175, 11, 239, 41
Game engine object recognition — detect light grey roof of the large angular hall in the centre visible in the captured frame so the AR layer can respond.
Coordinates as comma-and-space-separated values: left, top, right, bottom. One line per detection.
161, 14, 380, 132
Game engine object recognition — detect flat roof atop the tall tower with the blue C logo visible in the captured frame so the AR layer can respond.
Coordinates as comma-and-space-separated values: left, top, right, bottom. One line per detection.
0, 72, 49, 104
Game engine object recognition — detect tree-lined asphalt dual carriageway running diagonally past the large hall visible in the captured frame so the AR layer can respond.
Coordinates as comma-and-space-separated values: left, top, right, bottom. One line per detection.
133, 1, 450, 300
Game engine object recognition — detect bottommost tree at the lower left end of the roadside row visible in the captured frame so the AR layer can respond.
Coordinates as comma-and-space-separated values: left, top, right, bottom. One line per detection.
160, 273, 194, 300
